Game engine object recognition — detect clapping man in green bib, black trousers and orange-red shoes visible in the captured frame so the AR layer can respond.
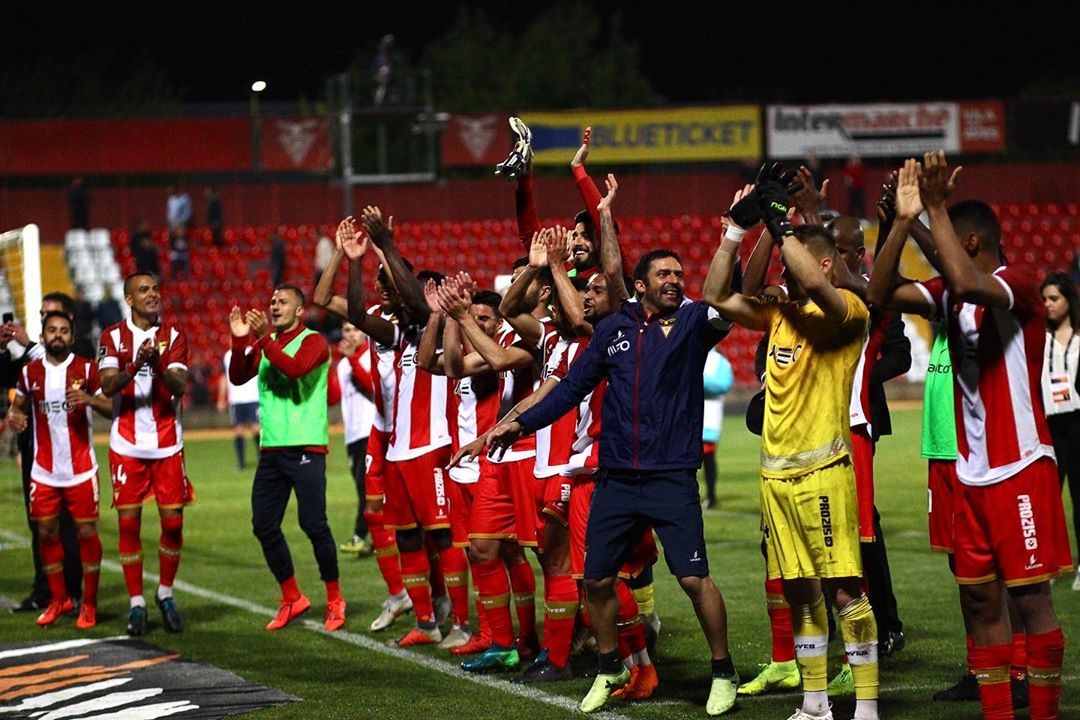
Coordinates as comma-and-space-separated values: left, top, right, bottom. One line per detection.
229, 285, 346, 630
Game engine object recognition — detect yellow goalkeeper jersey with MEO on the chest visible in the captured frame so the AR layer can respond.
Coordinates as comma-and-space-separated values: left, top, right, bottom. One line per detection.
754, 289, 869, 478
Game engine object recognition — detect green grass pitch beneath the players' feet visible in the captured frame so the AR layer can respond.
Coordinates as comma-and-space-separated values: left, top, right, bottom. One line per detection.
0, 410, 1080, 720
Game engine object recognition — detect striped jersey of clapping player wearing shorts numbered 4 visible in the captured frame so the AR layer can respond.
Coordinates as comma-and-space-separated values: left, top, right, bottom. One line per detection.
98, 320, 188, 460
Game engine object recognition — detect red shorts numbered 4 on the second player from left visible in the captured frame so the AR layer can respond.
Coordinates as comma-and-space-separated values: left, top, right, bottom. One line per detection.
109, 450, 195, 510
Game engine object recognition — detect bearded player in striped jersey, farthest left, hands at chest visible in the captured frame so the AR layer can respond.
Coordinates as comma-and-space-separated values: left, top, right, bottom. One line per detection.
8, 311, 112, 629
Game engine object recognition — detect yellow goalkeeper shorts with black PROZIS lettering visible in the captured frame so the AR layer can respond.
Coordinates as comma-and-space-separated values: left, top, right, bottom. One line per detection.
761, 458, 863, 580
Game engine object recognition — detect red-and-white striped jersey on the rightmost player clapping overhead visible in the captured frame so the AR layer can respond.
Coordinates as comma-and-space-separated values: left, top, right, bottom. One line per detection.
917, 268, 1054, 486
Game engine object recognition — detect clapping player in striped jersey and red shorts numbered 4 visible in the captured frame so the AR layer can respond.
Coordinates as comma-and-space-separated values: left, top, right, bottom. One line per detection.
98, 272, 195, 637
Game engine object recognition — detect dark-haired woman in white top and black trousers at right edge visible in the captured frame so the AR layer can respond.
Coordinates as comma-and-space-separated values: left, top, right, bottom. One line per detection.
1041, 272, 1080, 590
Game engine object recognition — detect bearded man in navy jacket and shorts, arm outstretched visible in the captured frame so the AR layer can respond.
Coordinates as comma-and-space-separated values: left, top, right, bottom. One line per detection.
491, 249, 738, 711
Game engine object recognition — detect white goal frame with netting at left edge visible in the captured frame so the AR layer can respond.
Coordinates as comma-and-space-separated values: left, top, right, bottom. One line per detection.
0, 223, 41, 338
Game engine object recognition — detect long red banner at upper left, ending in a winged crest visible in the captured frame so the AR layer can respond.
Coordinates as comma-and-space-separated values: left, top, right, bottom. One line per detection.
0, 118, 330, 175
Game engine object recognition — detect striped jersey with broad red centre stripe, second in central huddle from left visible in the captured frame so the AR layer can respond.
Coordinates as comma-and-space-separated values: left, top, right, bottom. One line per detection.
387, 317, 450, 462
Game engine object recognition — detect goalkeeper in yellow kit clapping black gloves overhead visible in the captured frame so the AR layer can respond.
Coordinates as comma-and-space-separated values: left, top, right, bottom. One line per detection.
705, 174, 878, 720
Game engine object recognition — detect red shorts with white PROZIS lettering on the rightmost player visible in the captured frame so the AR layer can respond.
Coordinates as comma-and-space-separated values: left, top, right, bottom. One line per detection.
956, 458, 1072, 586
